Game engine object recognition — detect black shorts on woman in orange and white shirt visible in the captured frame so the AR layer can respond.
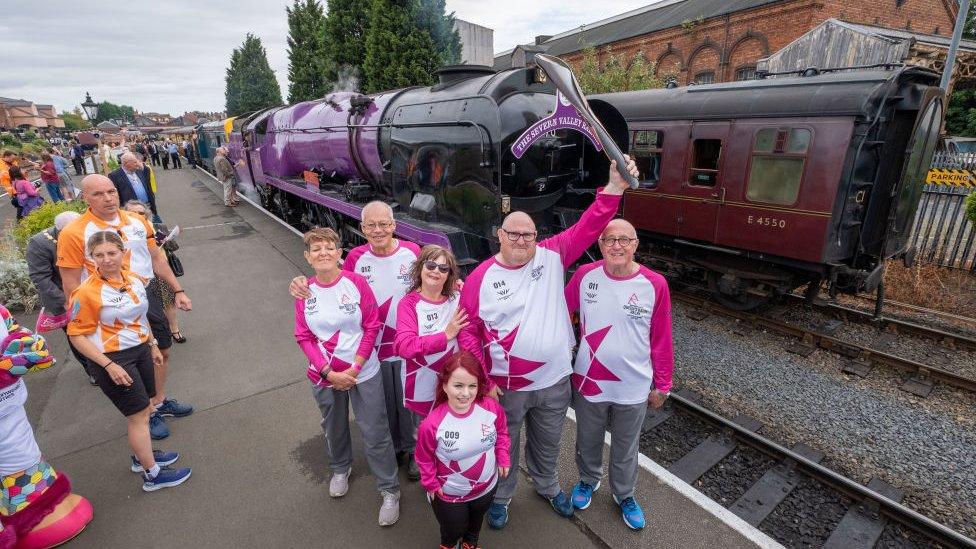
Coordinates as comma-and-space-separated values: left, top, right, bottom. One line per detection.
91, 343, 156, 416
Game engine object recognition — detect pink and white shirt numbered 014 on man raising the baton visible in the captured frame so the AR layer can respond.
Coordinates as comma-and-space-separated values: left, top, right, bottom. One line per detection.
458, 193, 620, 391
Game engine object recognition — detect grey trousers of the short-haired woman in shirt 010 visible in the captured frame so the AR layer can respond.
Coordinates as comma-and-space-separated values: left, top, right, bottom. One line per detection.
312, 376, 400, 492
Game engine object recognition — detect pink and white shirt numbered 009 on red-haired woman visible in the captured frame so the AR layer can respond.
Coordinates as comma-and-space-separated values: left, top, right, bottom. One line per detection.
415, 398, 515, 503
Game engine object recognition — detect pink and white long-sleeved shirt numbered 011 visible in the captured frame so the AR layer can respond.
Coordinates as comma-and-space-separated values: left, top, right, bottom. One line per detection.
566, 261, 674, 404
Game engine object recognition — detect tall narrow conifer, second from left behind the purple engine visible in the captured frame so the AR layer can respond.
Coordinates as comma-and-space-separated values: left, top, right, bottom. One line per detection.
285, 0, 332, 103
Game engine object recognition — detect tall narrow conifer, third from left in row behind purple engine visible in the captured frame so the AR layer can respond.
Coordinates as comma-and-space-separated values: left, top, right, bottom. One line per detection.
325, 0, 370, 91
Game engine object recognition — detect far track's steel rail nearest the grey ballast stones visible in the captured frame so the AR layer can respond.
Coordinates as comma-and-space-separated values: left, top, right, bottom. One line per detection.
672, 291, 976, 392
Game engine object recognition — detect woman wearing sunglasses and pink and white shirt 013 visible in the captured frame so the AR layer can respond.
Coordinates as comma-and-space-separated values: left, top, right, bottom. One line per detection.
396, 245, 468, 416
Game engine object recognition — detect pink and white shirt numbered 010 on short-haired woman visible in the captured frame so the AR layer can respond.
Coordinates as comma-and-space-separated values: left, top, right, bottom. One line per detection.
295, 271, 380, 387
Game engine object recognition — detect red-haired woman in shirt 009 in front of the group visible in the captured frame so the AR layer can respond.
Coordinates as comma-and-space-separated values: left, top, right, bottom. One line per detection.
416, 351, 511, 549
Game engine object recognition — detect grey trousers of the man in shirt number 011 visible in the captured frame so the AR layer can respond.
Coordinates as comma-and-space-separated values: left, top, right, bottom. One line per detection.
573, 391, 647, 501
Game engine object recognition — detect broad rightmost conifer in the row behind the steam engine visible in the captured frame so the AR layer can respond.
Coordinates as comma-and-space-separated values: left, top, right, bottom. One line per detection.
363, 0, 439, 93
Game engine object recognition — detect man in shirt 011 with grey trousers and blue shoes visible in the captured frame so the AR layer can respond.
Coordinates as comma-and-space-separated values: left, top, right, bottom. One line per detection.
566, 219, 674, 530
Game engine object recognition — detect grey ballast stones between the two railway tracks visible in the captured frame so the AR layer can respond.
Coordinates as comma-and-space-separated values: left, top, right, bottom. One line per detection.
668, 305, 976, 537
